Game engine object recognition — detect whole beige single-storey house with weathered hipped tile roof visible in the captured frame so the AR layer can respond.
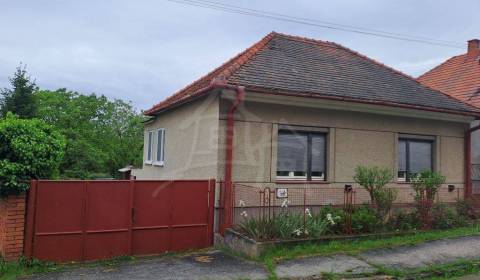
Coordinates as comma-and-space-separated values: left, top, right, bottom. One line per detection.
132, 32, 480, 230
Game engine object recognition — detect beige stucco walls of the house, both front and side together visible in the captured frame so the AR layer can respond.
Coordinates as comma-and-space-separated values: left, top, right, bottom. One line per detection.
134, 93, 468, 204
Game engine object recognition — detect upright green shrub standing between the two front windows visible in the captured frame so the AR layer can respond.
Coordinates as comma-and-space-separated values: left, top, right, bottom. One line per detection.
353, 166, 397, 221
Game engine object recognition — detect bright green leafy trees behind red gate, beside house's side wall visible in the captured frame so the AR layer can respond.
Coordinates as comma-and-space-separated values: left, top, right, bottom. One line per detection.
36, 89, 143, 178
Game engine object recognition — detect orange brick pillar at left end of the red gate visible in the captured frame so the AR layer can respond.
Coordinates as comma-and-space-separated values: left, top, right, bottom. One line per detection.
0, 194, 26, 261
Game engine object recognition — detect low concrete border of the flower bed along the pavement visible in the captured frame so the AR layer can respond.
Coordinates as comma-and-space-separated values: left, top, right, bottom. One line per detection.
223, 229, 418, 258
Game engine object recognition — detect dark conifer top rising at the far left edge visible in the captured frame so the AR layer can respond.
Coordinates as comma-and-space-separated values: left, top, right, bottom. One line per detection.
0, 65, 37, 119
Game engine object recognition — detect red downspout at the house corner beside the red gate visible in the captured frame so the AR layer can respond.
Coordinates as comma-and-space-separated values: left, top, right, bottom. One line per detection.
221, 86, 245, 234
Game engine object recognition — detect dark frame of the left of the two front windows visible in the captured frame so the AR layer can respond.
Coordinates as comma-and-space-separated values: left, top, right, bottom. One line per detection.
275, 129, 328, 182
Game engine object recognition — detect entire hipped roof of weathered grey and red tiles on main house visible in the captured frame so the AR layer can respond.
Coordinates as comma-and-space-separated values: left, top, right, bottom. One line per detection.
145, 32, 479, 115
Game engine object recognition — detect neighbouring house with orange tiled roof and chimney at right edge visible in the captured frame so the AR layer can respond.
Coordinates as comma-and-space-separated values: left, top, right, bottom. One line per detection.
418, 39, 480, 194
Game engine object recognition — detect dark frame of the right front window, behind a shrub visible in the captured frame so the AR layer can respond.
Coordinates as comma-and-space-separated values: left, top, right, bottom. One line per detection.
396, 135, 435, 183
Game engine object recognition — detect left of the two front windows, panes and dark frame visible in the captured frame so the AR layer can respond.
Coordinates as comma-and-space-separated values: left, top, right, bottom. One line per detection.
277, 130, 327, 181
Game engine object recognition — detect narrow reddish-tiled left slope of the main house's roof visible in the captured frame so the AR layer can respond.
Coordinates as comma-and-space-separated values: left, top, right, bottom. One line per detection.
145, 31, 278, 114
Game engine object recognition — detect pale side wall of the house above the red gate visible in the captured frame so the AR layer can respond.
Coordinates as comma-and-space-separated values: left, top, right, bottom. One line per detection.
133, 95, 219, 180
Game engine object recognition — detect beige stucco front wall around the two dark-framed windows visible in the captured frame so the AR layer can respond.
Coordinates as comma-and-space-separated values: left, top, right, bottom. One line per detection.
218, 96, 468, 204
